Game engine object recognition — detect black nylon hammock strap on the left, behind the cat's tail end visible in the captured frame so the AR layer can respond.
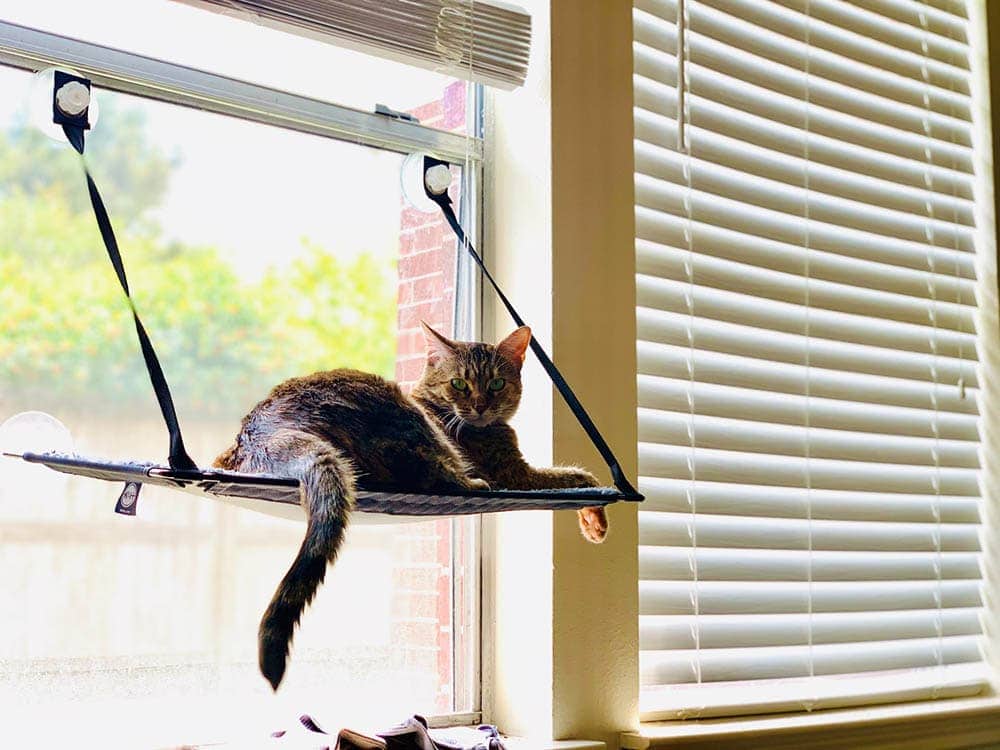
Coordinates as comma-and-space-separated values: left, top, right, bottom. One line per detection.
63, 123, 198, 471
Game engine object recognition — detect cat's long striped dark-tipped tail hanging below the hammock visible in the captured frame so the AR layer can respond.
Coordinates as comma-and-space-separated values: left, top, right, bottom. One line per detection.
249, 430, 354, 690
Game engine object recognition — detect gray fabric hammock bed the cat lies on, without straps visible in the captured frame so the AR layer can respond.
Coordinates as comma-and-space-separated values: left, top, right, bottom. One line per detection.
21, 453, 622, 517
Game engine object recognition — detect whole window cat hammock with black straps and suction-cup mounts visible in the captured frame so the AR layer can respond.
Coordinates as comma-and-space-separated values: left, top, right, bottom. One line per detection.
4, 75, 643, 518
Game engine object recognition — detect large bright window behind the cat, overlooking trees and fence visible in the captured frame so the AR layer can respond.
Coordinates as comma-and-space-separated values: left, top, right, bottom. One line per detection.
0, 3, 479, 746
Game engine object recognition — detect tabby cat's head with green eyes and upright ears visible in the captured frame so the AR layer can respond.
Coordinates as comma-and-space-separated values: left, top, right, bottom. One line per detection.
420, 323, 531, 427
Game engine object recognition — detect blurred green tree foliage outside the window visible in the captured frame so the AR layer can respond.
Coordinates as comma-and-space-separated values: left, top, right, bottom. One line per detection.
0, 97, 395, 417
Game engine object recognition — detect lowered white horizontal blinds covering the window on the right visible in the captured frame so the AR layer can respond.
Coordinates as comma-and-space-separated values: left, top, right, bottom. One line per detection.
633, 0, 985, 718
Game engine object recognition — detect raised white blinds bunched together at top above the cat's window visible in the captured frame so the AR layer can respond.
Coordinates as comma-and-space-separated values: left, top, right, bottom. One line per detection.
179, 0, 531, 89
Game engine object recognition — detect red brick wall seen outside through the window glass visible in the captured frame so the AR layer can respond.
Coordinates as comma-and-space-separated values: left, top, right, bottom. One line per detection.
393, 81, 466, 713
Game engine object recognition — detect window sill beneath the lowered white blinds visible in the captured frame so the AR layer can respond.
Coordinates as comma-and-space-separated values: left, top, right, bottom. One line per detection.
621, 696, 1000, 750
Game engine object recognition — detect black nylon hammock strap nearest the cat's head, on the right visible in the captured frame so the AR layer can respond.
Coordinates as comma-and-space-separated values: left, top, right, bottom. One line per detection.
424, 156, 642, 500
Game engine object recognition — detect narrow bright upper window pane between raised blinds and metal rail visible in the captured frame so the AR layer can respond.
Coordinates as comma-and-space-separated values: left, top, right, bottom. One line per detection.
0, 0, 465, 130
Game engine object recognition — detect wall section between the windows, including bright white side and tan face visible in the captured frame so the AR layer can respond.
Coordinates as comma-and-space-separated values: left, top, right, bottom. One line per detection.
484, 0, 638, 744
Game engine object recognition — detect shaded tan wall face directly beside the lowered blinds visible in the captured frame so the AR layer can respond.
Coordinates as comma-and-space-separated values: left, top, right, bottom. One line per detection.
551, 0, 639, 739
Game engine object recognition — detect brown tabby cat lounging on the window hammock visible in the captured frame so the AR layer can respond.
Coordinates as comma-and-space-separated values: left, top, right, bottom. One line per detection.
215, 323, 608, 690
